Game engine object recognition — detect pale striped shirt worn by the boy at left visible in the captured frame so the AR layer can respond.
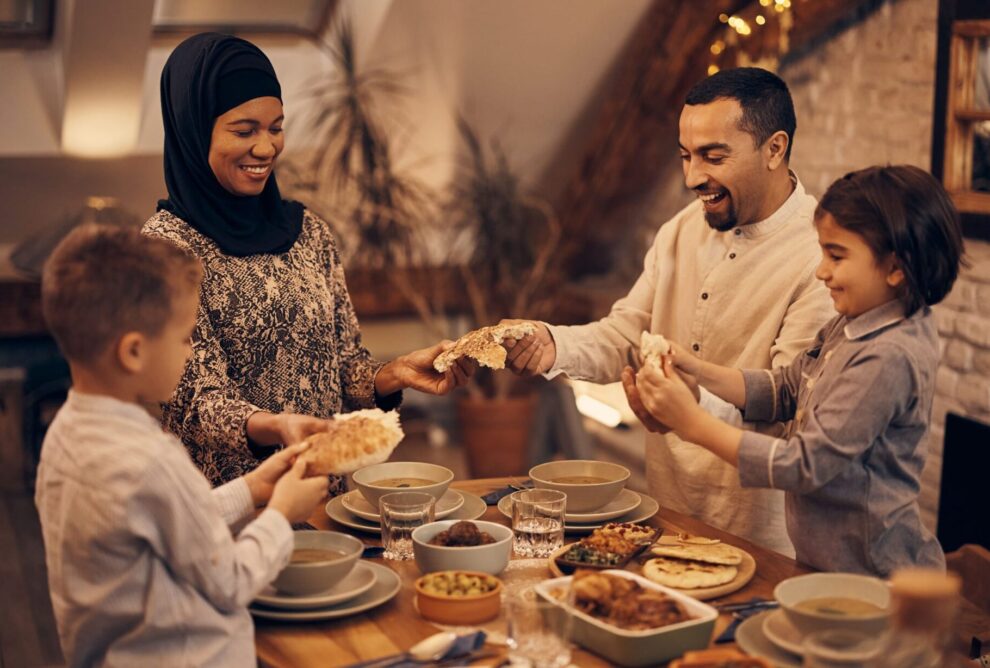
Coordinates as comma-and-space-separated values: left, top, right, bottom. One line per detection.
35, 391, 292, 668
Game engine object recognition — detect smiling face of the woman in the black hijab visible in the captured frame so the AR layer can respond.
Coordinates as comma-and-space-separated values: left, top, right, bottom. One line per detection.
209, 97, 285, 197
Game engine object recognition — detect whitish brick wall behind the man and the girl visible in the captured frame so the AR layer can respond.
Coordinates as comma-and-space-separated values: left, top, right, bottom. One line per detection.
780, 0, 990, 527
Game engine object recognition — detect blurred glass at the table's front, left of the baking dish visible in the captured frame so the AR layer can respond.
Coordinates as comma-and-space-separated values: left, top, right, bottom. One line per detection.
505, 587, 572, 668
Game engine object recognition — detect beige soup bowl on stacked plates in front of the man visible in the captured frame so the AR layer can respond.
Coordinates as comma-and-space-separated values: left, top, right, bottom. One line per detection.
529, 459, 630, 513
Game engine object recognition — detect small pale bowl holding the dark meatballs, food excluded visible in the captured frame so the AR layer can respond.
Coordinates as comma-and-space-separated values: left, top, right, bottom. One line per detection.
412, 520, 512, 575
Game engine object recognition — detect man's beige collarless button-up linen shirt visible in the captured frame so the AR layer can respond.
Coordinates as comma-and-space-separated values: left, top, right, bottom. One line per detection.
548, 178, 835, 554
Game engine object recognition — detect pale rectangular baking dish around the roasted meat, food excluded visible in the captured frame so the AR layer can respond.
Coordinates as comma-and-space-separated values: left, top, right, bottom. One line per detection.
536, 570, 718, 666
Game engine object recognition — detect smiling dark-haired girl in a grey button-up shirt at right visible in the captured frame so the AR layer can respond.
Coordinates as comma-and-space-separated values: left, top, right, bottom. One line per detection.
636, 166, 962, 576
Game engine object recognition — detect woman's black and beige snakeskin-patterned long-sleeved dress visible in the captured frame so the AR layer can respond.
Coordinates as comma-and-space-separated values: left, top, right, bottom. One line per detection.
143, 210, 401, 494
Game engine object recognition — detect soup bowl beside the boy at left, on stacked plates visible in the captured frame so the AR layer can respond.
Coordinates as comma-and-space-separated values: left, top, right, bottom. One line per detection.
272, 531, 364, 596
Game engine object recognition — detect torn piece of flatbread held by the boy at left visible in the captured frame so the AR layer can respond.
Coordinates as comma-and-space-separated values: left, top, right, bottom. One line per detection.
299, 408, 404, 476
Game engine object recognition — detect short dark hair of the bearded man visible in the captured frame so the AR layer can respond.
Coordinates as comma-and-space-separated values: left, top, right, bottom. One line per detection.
684, 67, 797, 161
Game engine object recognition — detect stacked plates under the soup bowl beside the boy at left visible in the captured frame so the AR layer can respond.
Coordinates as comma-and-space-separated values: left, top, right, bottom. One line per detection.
248, 561, 402, 622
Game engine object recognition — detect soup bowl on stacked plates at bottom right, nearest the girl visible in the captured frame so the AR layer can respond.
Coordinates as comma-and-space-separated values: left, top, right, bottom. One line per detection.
773, 573, 890, 634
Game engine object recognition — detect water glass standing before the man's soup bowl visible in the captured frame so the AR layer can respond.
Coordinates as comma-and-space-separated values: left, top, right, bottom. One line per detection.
510, 489, 567, 557
